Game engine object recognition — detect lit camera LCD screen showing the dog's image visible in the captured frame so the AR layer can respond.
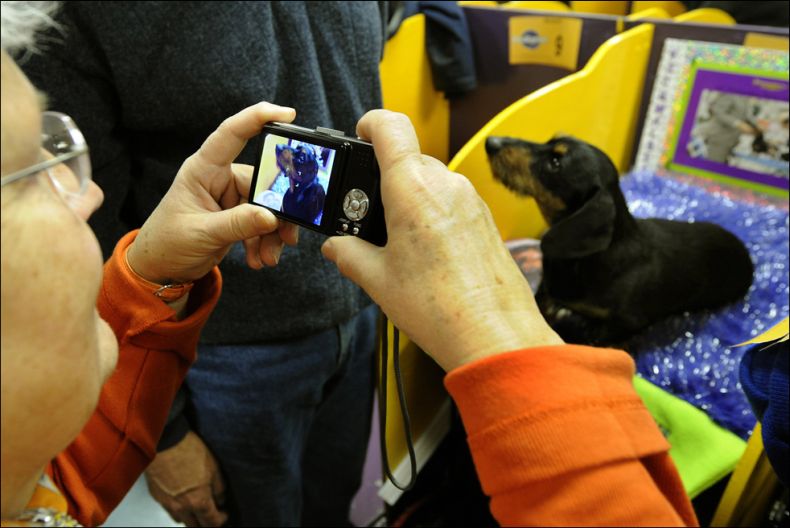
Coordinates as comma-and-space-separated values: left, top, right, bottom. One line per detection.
252, 134, 336, 226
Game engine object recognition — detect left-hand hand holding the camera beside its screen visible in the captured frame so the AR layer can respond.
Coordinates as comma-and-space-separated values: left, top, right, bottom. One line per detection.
127, 103, 298, 284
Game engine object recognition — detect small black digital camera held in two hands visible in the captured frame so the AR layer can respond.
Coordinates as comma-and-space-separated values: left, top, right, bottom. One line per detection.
249, 123, 387, 246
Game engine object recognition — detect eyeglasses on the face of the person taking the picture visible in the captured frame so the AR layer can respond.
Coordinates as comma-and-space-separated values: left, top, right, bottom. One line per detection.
0, 112, 91, 203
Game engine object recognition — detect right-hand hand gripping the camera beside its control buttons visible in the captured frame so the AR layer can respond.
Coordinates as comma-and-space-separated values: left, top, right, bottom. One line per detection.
322, 110, 562, 370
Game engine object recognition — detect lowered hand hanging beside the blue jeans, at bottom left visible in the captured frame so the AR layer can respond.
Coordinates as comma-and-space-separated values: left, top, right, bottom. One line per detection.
145, 431, 228, 526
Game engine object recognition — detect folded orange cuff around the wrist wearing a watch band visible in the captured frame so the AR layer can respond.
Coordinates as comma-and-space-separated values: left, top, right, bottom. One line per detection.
97, 230, 222, 361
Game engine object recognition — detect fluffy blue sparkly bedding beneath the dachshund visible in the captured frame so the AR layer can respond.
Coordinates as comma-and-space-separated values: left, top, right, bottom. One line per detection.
621, 172, 790, 439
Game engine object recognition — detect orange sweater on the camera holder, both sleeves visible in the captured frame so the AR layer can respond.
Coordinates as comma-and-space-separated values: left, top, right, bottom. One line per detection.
34, 233, 697, 526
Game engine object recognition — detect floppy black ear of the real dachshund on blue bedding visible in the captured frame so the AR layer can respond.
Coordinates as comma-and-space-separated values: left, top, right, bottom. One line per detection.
540, 189, 615, 259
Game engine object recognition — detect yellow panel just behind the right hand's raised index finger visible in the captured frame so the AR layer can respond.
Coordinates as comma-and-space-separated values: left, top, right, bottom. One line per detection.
379, 15, 450, 163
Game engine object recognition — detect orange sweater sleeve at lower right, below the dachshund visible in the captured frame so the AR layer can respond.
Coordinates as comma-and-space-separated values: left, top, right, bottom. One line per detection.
445, 345, 697, 526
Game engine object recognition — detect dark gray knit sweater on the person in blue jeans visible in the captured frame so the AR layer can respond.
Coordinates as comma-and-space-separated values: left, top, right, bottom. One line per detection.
22, 1, 392, 344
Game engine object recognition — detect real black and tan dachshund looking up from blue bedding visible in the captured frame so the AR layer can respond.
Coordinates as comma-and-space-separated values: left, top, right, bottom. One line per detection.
486, 136, 754, 346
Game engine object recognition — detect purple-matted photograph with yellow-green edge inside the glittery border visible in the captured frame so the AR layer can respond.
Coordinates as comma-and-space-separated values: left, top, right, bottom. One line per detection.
667, 62, 790, 196
